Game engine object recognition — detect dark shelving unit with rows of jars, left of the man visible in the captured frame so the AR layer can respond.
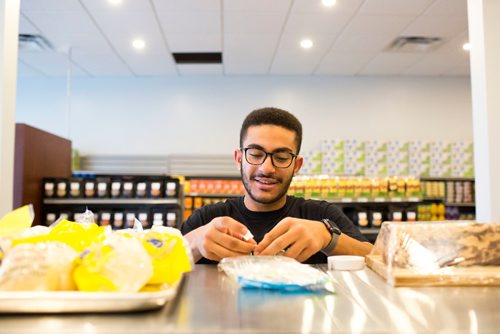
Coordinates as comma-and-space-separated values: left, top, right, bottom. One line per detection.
43, 175, 182, 228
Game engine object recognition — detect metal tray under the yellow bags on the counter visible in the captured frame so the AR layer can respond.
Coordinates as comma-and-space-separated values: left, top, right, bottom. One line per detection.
0, 282, 180, 313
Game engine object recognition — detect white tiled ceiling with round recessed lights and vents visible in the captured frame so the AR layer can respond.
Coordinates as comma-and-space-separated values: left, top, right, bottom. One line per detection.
19, 0, 469, 77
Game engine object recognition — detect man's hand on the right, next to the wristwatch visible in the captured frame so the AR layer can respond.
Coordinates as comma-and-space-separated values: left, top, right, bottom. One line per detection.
254, 217, 331, 262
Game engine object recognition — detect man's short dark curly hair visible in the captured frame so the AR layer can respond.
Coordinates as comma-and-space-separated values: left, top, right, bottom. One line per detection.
240, 107, 302, 154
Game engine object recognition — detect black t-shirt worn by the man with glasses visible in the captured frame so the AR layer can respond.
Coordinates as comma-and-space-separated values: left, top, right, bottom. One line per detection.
181, 196, 367, 263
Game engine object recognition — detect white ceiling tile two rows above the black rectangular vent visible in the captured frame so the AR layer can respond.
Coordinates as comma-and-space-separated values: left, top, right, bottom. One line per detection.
158, 11, 221, 35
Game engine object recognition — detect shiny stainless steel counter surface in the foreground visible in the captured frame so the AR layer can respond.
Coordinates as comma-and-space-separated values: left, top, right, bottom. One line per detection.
0, 265, 500, 333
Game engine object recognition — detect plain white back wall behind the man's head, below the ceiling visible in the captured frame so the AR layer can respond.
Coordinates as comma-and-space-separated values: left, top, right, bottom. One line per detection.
16, 77, 472, 155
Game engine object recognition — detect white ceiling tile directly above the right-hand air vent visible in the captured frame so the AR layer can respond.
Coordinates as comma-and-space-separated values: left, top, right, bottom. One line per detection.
401, 16, 467, 39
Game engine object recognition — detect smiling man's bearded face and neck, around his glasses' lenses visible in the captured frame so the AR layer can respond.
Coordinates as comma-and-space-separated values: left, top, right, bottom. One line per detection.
235, 125, 302, 211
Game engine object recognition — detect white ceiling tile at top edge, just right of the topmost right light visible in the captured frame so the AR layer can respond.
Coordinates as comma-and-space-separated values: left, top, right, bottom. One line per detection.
359, 0, 434, 16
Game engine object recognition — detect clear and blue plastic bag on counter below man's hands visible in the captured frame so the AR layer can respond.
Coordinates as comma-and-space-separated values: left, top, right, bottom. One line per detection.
219, 256, 334, 292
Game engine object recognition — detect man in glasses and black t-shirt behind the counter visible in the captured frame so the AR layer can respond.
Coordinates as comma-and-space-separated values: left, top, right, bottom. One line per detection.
181, 108, 372, 263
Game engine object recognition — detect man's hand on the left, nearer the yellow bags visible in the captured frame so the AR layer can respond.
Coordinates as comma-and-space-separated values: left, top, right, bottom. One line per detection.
186, 217, 256, 262
